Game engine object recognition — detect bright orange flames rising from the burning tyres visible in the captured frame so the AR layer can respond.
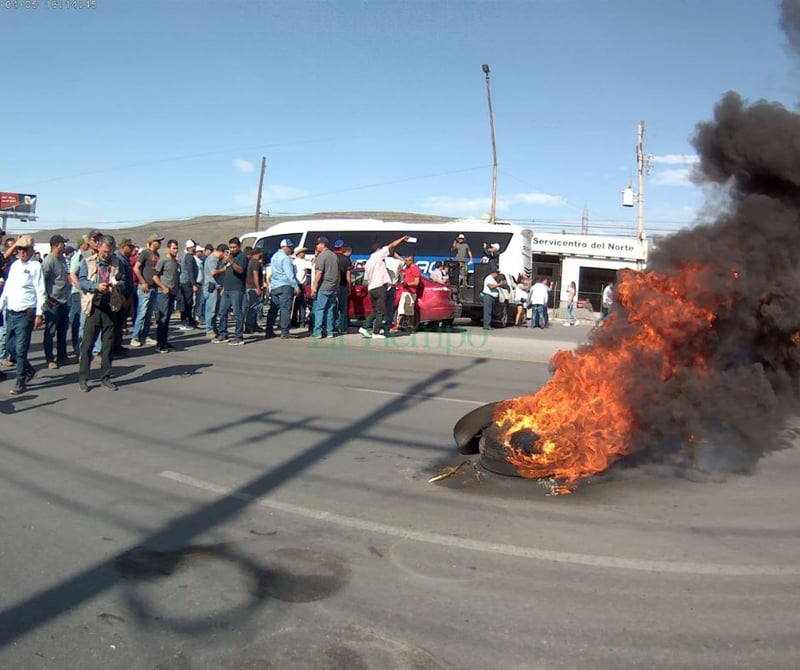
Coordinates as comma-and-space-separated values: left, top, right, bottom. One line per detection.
494, 266, 724, 493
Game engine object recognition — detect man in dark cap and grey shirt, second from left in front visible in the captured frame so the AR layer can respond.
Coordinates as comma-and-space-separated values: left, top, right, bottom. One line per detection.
42, 235, 71, 370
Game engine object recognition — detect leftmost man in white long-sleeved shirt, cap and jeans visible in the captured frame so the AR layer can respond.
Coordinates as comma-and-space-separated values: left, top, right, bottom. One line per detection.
0, 235, 47, 395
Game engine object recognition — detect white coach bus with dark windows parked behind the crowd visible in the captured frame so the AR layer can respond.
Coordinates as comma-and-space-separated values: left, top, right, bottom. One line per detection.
239, 219, 533, 322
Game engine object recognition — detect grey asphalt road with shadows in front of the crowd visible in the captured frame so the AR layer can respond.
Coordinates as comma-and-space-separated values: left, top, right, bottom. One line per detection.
0, 325, 800, 670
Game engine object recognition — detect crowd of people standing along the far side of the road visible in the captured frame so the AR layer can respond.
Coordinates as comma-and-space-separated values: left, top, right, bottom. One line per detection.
0, 230, 613, 395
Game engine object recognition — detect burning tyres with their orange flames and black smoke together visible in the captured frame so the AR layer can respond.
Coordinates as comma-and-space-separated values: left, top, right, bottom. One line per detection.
454, 93, 800, 493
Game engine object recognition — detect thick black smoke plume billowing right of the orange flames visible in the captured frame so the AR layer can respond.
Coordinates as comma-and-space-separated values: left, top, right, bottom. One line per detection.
620, 92, 800, 470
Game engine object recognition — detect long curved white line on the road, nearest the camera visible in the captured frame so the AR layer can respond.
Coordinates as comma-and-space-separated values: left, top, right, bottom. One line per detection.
159, 470, 800, 577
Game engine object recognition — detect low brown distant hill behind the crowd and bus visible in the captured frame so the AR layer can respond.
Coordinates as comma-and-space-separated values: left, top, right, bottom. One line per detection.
26, 212, 456, 246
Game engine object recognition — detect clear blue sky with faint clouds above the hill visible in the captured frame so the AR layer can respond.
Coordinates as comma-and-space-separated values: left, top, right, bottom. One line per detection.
0, 0, 798, 239
